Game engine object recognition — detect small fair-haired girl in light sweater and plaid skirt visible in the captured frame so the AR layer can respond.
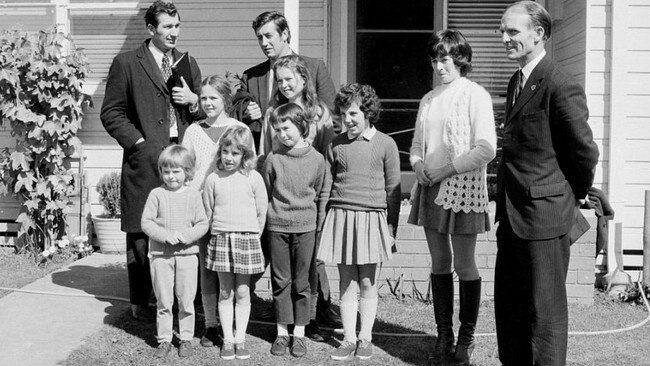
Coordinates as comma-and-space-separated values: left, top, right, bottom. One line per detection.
203, 125, 268, 360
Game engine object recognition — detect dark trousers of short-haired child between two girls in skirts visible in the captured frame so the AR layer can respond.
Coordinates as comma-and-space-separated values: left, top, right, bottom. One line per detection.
268, 231, 316, 325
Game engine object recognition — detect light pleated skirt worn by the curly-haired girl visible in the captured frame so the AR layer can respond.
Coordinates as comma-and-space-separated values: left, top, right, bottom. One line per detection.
316, 208, 395, 265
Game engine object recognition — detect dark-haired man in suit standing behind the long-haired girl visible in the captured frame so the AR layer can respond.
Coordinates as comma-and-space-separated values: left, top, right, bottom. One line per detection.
242, 11, 341, 341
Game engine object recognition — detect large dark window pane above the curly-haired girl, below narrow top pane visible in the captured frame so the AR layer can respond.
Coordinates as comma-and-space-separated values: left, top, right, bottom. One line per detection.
356, 33, 432, 99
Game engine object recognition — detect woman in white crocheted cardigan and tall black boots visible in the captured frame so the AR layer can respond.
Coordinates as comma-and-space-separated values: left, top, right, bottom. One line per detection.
409, 30, 496, 365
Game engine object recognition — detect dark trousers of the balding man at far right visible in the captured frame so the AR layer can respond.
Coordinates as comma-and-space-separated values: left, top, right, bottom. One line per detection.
494, 220, 570, 366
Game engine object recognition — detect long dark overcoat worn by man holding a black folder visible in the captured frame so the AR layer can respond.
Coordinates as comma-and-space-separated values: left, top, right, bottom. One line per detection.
100, 40, 201, 232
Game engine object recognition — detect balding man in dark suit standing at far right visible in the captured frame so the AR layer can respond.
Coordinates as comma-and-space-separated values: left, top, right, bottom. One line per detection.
494, 1, 598, 366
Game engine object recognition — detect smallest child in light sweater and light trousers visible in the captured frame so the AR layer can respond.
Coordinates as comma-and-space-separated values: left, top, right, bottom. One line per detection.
141, 145, 208, 358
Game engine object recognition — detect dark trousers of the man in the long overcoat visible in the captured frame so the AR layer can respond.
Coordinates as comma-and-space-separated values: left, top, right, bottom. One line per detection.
126, 233, 152, 306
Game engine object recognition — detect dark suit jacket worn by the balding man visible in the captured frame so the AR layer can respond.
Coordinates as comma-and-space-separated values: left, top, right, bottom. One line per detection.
496, 56, 598, 240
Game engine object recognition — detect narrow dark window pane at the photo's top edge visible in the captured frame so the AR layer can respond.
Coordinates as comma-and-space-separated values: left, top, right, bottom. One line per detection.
357, 0, 433, 30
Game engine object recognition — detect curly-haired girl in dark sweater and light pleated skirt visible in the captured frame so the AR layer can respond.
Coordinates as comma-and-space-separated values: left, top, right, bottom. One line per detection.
317, 83, 401, 360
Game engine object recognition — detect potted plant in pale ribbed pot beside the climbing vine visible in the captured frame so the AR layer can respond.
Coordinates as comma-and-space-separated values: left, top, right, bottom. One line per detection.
93, 172, 126, 253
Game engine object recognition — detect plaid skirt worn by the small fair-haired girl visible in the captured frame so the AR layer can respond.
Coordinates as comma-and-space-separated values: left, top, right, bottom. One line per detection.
205, 232, 264, 274
